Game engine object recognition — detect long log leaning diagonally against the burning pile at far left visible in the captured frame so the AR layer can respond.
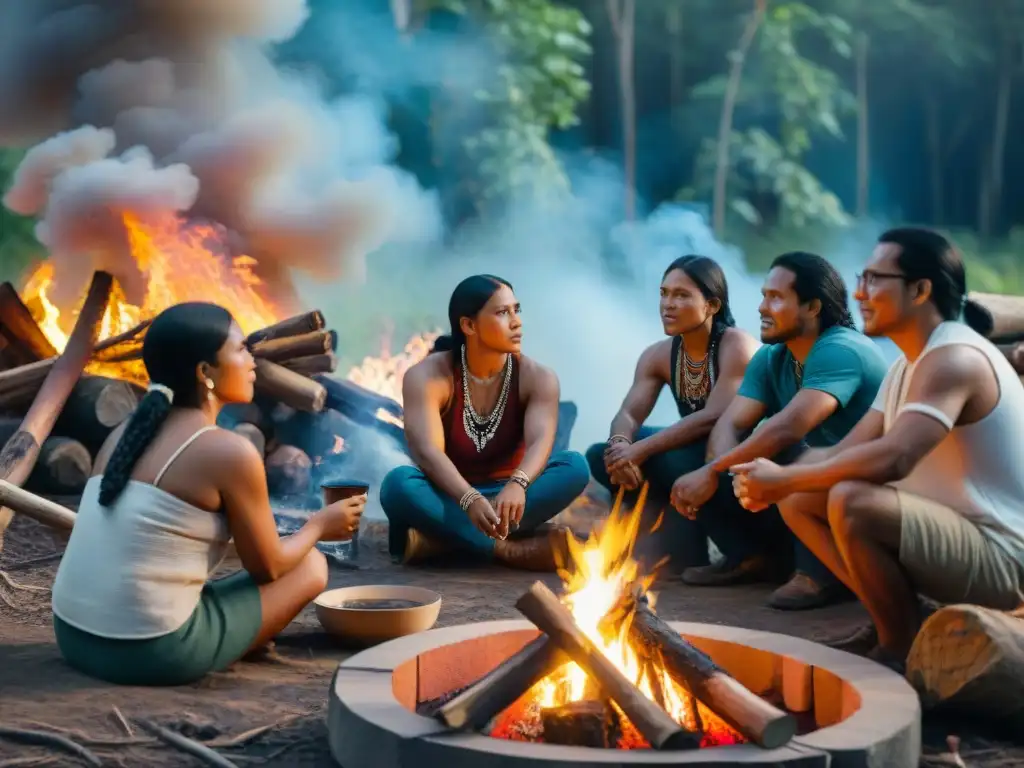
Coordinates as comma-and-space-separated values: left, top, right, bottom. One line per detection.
0, 272, 114, 545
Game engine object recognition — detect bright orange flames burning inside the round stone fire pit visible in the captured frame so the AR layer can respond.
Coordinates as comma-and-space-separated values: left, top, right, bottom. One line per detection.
492, 484, 743, 749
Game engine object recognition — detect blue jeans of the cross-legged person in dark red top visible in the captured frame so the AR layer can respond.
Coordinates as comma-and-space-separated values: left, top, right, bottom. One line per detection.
380, 451, 590, 559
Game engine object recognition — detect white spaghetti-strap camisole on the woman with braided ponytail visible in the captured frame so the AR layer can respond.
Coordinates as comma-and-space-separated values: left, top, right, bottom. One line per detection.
53, 427, 230, 640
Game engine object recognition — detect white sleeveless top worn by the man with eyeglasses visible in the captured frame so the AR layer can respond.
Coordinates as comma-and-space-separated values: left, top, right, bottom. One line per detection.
874, 322, 1024, 564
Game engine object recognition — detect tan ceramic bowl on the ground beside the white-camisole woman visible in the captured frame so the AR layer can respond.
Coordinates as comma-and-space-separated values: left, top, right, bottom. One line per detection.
314, 585, 441, 645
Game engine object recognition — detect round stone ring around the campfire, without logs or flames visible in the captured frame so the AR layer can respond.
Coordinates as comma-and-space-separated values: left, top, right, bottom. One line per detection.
328, 621, 921, 768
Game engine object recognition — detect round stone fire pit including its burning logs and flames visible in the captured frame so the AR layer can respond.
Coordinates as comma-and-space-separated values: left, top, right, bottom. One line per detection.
329, 486, 921, 768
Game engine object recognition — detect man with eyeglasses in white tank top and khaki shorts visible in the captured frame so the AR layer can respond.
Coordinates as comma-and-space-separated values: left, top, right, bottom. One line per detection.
733, 227, 1024, 669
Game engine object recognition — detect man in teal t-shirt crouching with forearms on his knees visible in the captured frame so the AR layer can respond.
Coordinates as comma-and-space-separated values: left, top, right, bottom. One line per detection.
672, 252, 888, 610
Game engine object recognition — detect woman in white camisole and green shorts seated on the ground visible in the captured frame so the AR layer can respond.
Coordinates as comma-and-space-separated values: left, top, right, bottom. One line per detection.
53, 303, 366, 685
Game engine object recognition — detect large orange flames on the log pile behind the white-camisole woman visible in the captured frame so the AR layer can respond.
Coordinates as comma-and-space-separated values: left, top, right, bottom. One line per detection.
22, 214, 280, 383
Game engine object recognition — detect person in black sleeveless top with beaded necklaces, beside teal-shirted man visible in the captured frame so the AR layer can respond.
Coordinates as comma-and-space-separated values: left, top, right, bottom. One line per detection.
587, 256, 759, 573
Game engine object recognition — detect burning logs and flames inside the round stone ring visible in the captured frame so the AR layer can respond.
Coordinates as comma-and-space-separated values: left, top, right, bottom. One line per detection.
418, 486, 798, 750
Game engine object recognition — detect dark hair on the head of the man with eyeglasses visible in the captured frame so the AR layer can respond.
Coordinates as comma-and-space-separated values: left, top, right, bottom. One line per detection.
879, 226, 967, 321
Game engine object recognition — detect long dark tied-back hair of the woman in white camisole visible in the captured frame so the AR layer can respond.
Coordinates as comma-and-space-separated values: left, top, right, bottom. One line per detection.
99, 302, 233, 507
